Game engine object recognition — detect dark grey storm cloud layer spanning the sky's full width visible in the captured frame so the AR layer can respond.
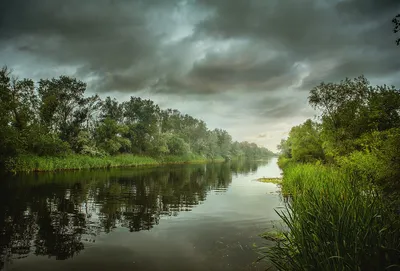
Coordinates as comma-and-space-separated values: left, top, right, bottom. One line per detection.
0, 0, 400, 94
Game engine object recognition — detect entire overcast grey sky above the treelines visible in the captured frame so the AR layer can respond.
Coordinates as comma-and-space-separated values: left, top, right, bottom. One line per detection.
0, 0, 400, 151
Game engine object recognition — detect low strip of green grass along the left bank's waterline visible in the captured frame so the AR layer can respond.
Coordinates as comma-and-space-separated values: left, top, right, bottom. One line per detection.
6, 154, 223, 172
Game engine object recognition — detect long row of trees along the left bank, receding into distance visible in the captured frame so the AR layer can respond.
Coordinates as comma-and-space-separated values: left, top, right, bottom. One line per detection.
0, 68, 273, 170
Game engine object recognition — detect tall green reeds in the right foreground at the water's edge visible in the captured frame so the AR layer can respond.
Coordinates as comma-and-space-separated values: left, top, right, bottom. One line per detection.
267, 165, 400, 270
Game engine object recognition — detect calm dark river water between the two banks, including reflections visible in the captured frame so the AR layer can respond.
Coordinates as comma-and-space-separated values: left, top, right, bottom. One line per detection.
0, 159, 281, 271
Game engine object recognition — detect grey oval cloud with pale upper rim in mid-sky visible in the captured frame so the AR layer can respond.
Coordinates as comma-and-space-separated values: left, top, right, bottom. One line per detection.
154, 41, 297, 94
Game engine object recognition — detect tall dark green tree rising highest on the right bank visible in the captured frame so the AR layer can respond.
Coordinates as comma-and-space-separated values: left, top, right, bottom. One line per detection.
309, 76, 400, 157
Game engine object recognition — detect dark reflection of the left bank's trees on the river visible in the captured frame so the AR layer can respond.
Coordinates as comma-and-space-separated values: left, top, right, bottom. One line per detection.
0, 162, 257, 268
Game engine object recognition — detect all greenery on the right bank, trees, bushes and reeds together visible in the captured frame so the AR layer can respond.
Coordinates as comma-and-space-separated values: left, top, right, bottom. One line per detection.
269, 76, 400, 270
